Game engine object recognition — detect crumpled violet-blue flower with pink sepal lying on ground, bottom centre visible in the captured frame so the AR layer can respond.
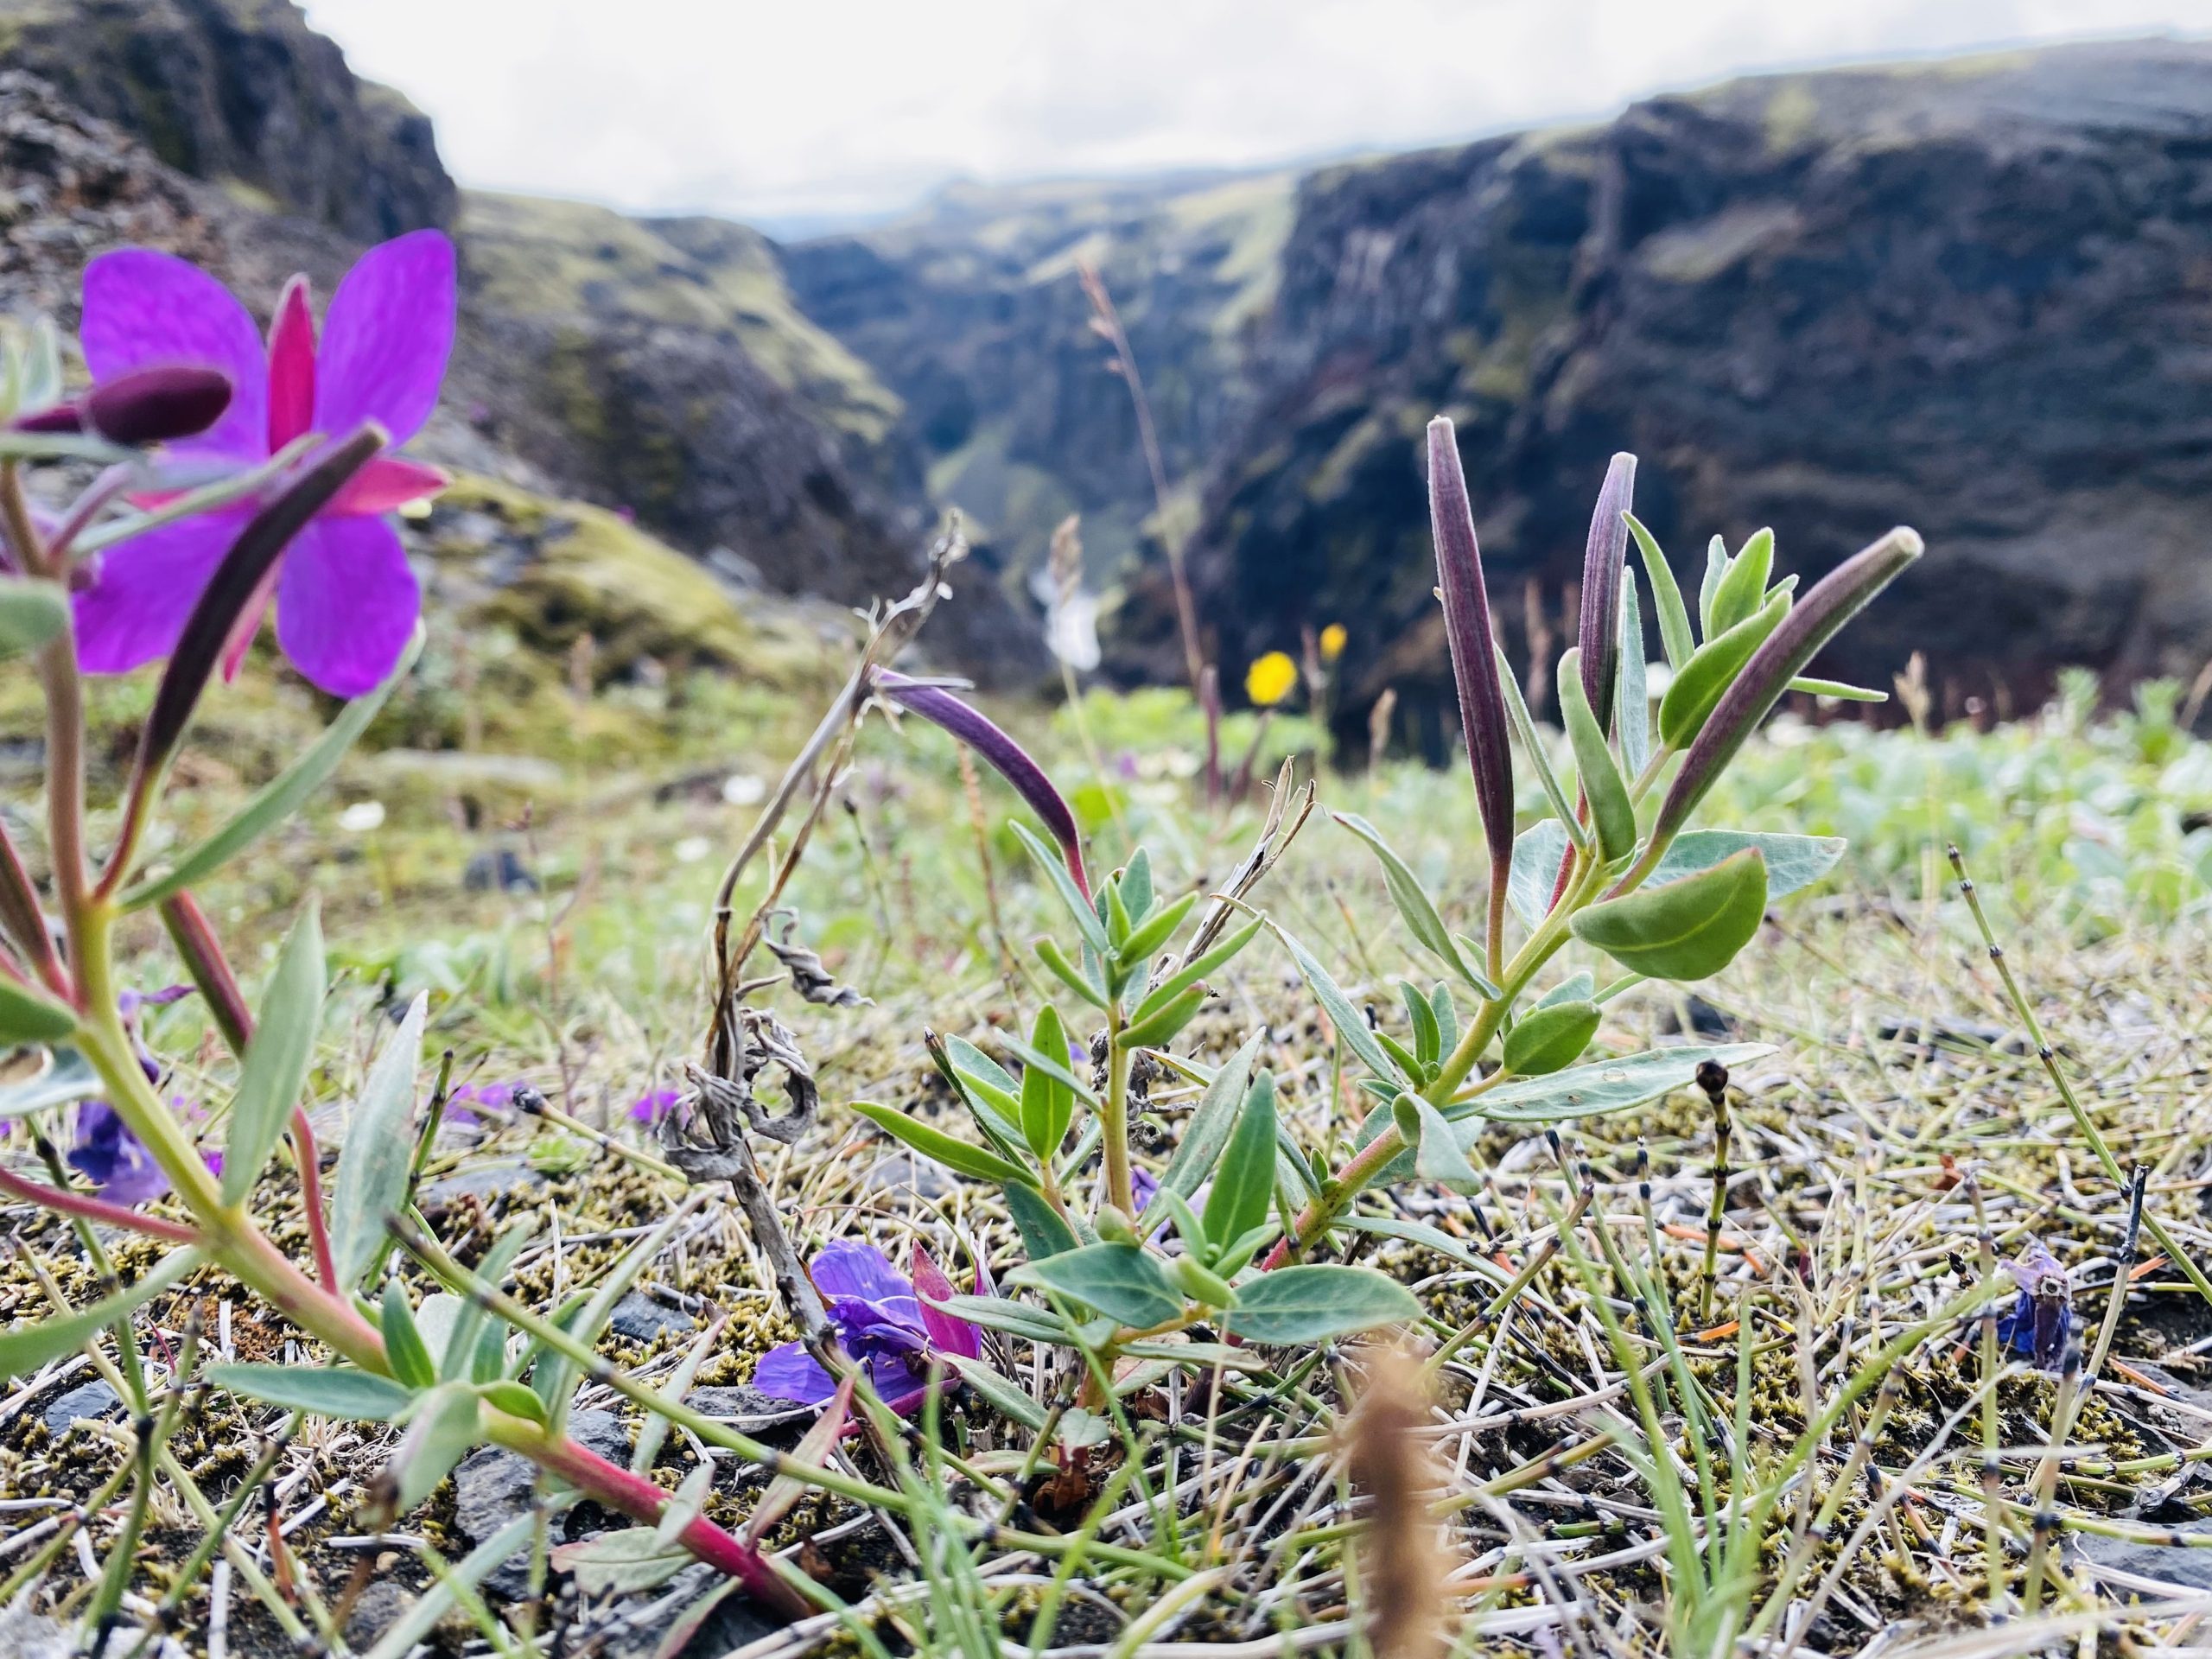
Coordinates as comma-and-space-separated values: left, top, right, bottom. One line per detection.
752, 1241, 982, 1411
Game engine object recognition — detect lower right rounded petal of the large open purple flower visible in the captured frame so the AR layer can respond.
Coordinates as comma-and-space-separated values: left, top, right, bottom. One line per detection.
276, 515, 423, 696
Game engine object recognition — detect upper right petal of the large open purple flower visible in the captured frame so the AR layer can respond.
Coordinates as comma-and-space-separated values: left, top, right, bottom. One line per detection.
315, 230, 454, 445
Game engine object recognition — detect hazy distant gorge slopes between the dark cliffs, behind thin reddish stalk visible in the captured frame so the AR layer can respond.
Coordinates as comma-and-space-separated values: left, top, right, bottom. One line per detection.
783, 173, 1294, 580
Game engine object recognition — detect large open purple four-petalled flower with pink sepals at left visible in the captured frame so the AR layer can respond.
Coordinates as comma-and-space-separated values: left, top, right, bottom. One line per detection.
75, 230, 454, 696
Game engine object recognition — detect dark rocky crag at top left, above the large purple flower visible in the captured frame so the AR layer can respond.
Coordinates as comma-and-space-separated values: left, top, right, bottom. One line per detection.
0, 0, 455, 241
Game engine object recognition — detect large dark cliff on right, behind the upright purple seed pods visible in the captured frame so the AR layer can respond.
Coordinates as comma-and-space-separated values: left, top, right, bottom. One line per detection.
1123, 42, 2212, 729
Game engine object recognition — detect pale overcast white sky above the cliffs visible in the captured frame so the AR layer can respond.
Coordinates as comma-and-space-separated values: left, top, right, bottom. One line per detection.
305, 0, 2212, 221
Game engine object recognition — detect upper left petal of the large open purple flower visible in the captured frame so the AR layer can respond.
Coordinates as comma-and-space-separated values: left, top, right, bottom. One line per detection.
79, 248, 268, 460
